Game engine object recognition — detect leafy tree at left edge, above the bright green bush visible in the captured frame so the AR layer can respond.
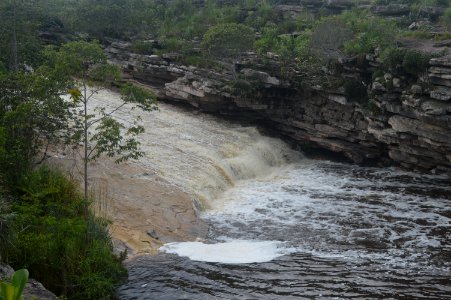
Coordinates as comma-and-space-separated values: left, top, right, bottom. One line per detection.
0, 69, 69, 187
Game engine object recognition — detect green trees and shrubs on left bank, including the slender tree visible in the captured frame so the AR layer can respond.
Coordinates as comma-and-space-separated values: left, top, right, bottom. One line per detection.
0, 2, 155, 299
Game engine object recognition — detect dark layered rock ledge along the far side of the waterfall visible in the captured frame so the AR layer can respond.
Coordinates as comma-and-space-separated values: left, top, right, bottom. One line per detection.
105, 41, 451, 174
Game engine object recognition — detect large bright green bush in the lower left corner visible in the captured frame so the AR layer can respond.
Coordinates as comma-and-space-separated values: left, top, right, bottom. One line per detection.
6, 167, 125, 299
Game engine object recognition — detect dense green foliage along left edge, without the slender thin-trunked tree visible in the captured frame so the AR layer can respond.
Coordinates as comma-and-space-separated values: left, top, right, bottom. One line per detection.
0, 59, 129, 299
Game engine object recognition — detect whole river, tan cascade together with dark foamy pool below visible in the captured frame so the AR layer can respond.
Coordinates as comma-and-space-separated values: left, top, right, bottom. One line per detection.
90, 90, 451, 299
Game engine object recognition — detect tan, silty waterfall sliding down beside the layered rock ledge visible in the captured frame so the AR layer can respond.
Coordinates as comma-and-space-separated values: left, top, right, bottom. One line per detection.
93, 91, 301, 208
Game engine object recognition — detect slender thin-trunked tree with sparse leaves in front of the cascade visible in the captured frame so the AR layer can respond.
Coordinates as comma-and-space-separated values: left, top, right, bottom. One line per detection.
47, 41, 157, 216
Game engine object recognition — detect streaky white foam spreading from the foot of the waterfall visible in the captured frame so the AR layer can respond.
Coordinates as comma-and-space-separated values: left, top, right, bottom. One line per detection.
202, 160, 451, 267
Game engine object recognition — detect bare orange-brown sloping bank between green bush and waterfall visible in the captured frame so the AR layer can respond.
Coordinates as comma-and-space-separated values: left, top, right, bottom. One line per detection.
50, 154, 207, 257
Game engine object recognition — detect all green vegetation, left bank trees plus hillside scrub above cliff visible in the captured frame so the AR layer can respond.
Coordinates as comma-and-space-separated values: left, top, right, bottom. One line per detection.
0, 0, 451, 299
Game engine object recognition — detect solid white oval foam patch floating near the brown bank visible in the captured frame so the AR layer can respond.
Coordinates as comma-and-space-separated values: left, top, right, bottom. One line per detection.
160, 240, 294, 264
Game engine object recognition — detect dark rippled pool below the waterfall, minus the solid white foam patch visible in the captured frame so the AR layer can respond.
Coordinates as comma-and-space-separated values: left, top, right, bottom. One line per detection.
119, 161, 451, 299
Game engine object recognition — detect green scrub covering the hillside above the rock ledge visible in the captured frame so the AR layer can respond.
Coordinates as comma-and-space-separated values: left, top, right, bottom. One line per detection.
0, 0, 451, 72
